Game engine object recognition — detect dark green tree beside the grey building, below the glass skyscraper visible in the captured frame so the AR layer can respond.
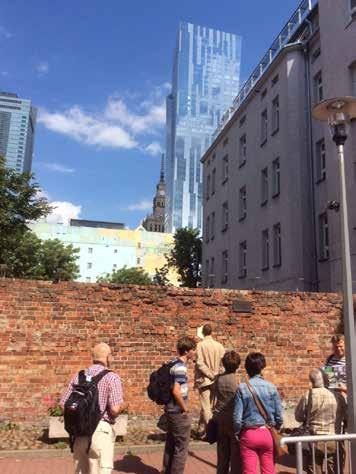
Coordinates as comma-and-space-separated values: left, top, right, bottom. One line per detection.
167, 227, 202, 288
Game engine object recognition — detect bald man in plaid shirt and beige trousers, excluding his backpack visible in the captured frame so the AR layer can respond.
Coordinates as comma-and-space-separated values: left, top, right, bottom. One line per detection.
60, 342, 126, 474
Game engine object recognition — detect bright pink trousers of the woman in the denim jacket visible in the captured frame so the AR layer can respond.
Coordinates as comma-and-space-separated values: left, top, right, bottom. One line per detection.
240, 427, 276, 474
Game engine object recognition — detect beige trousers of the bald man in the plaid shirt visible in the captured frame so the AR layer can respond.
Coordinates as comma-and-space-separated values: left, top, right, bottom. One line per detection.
73, 421, 116, 474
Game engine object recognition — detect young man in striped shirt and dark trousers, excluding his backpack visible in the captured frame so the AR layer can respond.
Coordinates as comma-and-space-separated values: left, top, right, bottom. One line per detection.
162, 336, 196, 474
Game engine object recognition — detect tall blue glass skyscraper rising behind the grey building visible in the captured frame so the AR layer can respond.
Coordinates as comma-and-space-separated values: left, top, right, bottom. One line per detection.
166, 22, 241, 231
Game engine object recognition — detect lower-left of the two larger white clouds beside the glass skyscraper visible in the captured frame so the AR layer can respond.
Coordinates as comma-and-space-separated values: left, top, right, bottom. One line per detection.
38, 106, 138, 149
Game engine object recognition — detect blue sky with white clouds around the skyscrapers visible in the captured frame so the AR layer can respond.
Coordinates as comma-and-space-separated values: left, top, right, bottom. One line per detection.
0, 0, 298, 227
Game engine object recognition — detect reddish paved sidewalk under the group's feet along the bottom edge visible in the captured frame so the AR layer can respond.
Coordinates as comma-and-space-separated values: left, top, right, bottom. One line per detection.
0, 449, 295, 474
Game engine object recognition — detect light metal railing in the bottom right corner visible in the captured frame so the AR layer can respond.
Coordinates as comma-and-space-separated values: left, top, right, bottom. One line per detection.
281, 434, 356, 474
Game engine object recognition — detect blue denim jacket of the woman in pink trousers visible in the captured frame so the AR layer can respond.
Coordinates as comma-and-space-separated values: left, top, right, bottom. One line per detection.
233, 375, 283, 433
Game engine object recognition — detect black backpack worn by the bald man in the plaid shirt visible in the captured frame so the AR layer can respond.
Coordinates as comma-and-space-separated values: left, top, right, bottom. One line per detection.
64, 369, 110, 452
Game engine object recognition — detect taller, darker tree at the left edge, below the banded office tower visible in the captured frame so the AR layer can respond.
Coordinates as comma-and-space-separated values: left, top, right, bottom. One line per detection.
0, 157, 51, 264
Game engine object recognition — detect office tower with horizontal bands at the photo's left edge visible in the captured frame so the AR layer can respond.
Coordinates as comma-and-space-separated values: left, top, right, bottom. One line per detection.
0, 92, 36, 173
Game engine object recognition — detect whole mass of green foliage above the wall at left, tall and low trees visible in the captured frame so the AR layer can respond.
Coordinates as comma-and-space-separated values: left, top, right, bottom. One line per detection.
0, 157, 79, 281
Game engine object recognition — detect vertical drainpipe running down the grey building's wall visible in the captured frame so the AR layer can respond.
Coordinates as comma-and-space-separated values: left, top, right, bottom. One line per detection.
303, 18, 319, 291
